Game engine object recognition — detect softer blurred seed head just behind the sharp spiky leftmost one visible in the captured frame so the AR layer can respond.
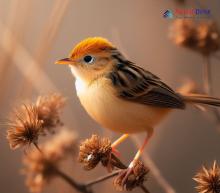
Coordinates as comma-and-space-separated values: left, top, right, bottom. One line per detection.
36, 94, 65, 132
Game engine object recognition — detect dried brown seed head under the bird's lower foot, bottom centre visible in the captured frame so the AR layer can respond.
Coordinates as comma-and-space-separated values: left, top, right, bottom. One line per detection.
113, 161, 149, 191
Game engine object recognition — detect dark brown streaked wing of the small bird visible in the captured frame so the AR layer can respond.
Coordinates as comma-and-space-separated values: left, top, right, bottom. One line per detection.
108, 62, 185, 109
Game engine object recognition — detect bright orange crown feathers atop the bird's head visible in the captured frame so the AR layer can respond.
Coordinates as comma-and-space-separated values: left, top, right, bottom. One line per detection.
69, 37, 114, 58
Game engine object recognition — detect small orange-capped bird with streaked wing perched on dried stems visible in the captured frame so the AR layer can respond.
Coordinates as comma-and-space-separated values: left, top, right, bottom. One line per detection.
56, 37, 220, 180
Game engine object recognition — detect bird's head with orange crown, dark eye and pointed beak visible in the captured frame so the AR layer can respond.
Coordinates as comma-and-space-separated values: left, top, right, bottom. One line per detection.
56, 37, 117, 82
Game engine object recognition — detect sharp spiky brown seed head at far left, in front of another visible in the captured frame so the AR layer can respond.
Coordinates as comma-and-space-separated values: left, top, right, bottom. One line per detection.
7, 105, 43, 149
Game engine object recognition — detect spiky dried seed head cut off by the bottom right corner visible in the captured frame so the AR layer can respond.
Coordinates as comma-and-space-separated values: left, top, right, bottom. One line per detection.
193, 161, 220, 193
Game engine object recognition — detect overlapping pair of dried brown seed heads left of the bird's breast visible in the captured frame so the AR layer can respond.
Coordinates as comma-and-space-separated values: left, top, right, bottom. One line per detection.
7, 94, 65, 149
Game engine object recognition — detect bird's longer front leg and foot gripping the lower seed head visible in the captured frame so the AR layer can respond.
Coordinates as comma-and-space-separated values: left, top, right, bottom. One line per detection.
121, 131, 153, 185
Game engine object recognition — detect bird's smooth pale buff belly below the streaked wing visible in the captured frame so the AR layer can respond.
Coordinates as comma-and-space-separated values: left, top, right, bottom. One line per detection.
78, 82, 170, 133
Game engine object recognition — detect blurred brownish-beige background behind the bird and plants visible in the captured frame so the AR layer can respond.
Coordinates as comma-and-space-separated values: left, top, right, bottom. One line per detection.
0, 0, 220, 193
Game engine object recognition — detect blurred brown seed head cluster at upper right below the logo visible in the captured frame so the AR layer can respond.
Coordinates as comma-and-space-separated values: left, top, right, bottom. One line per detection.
170, 19, 220, 55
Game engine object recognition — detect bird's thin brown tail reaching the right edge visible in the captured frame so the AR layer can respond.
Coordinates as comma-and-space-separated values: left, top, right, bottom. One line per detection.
182, 94, 220, 107
